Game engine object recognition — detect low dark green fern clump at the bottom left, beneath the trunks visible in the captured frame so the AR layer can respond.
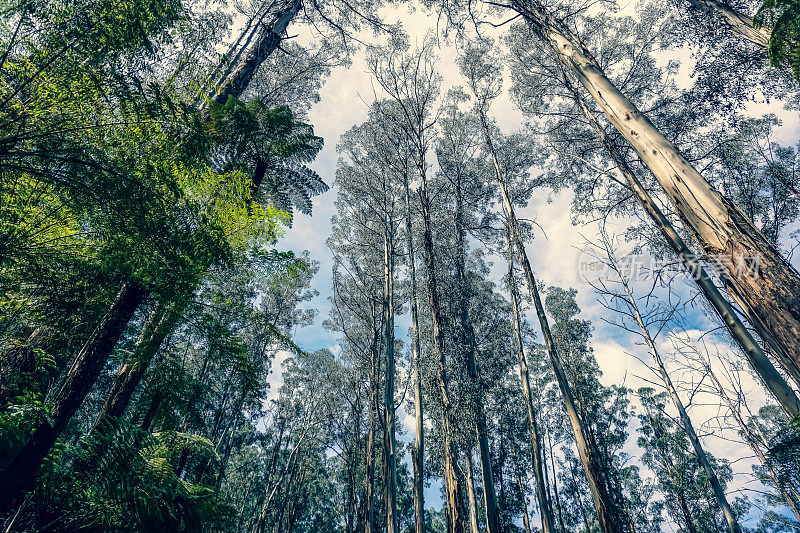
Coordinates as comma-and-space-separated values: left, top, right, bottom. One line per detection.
39, 423, 225, 531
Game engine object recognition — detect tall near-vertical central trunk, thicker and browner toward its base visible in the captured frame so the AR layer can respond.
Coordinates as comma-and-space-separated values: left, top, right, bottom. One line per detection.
418, 151, 464, 533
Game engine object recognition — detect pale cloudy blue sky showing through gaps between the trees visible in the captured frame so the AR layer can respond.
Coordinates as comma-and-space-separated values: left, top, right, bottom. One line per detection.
271, 4, 800, 525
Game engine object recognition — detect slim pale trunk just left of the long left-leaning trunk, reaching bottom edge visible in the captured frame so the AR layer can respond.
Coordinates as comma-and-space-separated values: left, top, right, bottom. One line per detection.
506, 228, 555, 533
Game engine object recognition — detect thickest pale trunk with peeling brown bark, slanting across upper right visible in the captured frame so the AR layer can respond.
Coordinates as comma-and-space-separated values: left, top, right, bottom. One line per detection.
513, 0, 800, 386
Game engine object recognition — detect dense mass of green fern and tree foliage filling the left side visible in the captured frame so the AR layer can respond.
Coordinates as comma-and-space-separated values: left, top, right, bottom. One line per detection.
0, 0, 327, 531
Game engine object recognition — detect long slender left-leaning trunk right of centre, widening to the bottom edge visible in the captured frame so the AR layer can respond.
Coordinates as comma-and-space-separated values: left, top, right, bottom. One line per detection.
480, 105, 625, 533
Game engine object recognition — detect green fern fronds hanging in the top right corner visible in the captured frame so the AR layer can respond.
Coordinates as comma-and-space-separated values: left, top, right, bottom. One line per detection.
753, 0, 800, 81
